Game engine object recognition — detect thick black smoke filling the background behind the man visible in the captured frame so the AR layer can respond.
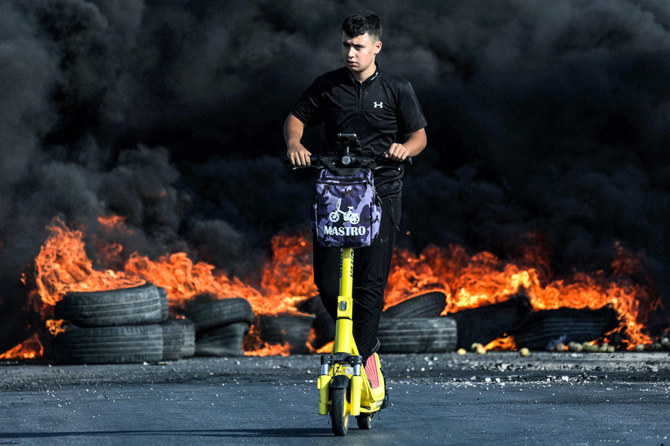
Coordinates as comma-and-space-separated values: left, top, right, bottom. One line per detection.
0, 0, 670, 352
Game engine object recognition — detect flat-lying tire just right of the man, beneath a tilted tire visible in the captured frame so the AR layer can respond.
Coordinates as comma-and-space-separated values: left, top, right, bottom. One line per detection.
377, 317, 456, 353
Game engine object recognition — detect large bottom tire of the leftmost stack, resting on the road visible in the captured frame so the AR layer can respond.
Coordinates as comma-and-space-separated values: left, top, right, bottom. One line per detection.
53, 324, 163, 364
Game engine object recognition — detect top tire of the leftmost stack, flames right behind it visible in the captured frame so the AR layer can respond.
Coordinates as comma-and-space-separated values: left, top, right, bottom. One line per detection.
54, 283, 163, 327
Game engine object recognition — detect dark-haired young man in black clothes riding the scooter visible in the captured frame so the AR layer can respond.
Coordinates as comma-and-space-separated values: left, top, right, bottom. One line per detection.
284, 11, 427, 398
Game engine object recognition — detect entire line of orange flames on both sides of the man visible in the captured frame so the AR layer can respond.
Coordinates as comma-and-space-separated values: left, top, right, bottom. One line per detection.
3, 216, 660, 356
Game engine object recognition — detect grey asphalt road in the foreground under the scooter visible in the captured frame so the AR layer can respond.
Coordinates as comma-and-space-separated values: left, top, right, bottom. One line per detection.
0, 353, 670, 445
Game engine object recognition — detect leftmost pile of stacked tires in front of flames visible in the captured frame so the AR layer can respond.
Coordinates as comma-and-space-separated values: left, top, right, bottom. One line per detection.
53, 283, 195, 364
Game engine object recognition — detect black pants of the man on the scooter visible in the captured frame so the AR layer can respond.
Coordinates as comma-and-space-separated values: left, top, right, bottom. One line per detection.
314, 197, 401, 361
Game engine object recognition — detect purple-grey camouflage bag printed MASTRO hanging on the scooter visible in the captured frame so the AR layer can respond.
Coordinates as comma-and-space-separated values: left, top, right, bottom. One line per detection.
312, 169, 382, 248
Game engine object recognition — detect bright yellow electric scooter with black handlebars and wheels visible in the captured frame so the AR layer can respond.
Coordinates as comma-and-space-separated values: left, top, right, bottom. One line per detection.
294, 134, 400, 436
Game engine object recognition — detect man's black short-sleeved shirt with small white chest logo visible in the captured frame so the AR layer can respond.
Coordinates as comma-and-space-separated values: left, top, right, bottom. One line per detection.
292, 66, 426, 196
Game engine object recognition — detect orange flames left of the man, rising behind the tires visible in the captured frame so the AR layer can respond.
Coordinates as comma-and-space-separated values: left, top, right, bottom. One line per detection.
35, 217, 315, 314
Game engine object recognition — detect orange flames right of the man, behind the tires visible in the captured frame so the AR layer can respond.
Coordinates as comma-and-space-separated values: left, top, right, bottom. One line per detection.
386, 240, 661, 349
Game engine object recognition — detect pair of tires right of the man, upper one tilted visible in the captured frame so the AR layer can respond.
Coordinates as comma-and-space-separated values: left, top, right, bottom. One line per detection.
377, 292, 457, 353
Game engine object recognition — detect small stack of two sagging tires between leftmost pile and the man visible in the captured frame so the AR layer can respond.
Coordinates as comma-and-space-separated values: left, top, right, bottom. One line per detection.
184, 296, 255, 356
